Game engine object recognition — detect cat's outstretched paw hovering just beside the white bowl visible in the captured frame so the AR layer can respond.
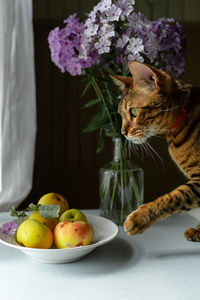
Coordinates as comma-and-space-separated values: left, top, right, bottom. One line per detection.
124, 204, 153, 235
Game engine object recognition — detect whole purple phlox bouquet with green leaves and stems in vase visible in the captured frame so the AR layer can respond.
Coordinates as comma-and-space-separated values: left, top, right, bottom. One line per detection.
48, 0, 185, 222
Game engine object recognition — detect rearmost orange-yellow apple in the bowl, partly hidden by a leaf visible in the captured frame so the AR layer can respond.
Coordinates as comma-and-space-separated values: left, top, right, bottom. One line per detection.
38, 193, 69, 216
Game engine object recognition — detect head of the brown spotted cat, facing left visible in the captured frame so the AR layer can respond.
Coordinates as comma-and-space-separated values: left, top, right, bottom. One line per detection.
112, 61, 173, 144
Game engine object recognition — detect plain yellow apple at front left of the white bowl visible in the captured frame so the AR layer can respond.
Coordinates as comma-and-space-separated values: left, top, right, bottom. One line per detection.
16, 219, 53, 249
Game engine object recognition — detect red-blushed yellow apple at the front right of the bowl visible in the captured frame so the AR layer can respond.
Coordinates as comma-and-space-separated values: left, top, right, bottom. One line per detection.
54, 221, 92, 248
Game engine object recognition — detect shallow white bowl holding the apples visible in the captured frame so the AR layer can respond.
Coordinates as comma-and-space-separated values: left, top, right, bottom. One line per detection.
0, 214, 118, 264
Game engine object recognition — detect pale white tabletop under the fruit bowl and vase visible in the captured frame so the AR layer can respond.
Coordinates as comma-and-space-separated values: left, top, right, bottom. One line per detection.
0, 210, 200, 300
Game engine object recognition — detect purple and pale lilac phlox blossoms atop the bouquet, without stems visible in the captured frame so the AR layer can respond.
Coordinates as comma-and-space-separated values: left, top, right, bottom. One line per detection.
48, 0, 185, 77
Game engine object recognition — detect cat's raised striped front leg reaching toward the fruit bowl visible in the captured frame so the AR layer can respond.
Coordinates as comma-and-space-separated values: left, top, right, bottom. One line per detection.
124, 180, 200, 235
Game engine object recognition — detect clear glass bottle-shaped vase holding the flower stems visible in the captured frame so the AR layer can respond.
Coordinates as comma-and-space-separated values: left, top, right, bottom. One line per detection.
99, 138, 144, 225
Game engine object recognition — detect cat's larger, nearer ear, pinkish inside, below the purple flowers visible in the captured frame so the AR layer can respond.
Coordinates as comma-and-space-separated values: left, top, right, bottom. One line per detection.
128, 60, 165, 88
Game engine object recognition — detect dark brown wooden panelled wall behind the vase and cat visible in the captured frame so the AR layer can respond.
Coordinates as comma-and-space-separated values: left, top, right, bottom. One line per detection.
21, 0, 200, 208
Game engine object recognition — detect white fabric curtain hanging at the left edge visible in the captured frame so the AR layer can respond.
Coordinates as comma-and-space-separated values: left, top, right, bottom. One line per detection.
0, 0, 36, 211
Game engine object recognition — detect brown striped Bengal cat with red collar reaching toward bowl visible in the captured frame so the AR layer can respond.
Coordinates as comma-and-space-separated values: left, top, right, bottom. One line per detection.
112, 61, 200, 242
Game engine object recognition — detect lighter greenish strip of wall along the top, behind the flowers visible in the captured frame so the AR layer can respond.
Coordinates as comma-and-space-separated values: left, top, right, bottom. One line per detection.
33, 0, 200, 22
